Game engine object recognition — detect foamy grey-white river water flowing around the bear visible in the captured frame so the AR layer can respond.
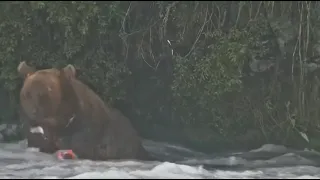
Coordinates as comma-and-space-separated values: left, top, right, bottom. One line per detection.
0, 140, 320, 179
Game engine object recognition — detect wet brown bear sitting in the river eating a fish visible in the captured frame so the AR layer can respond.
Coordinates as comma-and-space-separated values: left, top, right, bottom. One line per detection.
18, 62, 151, 160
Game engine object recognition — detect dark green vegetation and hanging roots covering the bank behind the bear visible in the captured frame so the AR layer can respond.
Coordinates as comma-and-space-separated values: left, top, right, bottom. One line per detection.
0, 1, 320, 150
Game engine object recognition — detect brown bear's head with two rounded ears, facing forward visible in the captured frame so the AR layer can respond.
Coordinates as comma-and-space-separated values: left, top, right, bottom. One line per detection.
17, 61, 78, 146
